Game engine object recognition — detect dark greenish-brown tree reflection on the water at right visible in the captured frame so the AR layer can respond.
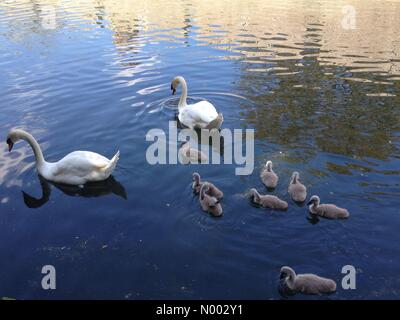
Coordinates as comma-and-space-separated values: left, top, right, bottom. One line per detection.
240, 52, 400, 160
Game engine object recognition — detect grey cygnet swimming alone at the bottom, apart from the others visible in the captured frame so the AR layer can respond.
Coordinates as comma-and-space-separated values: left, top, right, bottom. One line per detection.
280, 266, 336, 295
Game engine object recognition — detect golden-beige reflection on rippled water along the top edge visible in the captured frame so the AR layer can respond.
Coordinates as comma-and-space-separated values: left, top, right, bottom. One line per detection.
0, 0, 400, 75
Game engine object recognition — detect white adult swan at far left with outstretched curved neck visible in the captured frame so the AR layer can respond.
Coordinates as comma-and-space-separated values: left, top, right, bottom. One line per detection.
7, 129, 119, 185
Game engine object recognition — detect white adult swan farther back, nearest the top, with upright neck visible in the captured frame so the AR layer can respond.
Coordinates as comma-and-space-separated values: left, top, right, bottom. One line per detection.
171, 76, 224, 129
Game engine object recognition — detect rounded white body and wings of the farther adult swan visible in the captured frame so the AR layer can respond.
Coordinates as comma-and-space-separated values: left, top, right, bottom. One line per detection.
179, 101, 218, 127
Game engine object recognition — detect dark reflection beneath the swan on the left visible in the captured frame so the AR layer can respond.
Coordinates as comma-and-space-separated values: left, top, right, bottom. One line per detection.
22, 175, 128, 209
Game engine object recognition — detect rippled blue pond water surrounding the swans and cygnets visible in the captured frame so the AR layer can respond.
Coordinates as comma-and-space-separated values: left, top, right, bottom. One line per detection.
0, 0, 400, 299
